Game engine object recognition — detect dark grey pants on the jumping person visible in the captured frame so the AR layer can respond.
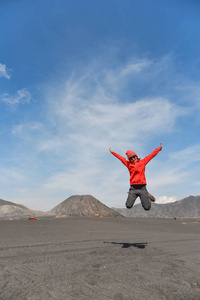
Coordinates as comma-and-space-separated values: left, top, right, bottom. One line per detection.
126, 184, 151, 210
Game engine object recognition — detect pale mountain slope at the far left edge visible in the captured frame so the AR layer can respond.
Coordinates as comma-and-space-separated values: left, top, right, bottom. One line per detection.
0, 199, 46, 220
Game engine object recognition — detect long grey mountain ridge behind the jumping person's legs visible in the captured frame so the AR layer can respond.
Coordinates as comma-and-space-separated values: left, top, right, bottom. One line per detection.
112, 196, 200, 218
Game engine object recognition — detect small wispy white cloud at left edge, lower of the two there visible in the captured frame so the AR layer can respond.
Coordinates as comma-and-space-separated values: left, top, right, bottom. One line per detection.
1, 89, 31, 105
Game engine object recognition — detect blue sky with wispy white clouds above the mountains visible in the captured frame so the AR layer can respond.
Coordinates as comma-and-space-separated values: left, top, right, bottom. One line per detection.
0, 0, 200, 210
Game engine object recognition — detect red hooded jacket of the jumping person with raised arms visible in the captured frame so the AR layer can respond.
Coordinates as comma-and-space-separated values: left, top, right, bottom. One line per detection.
111, 147, 162, 185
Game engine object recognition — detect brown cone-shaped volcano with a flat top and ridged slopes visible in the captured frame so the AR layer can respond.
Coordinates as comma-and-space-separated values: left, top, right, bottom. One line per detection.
49, 195, 122, 217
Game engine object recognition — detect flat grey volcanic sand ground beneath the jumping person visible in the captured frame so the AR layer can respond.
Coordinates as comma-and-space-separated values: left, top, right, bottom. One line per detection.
0, 217, 200, 300
